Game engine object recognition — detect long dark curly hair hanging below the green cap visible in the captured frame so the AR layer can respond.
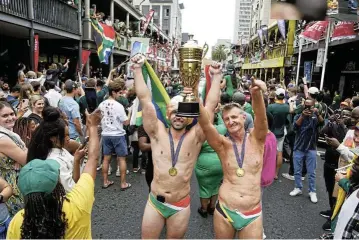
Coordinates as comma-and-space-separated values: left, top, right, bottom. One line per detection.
21, 182, 68, 239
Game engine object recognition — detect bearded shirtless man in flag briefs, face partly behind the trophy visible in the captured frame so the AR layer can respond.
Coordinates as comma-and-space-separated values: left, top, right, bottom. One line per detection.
132, 56, 222, 239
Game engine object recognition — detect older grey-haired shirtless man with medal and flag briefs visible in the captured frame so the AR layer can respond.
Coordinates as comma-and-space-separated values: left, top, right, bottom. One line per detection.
199, 78, 268, 239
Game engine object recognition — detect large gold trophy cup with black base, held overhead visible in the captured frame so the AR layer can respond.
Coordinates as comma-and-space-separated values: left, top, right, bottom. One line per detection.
177, 35, 208, 118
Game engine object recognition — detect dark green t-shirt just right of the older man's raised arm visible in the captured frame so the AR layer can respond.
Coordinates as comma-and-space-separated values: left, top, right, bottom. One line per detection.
267, 103, 289, 138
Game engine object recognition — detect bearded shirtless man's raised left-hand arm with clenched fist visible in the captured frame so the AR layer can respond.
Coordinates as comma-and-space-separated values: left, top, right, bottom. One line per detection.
132, 55, 159, 138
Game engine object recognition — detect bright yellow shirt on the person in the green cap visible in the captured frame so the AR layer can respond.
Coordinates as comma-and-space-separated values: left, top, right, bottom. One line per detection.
6, 173, 95, 239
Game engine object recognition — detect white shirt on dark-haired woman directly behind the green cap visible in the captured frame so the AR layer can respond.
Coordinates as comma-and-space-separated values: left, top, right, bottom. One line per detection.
47, 148, 76, 193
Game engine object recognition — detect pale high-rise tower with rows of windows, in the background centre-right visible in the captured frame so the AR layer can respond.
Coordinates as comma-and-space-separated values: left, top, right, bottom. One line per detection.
233, 0, 252, 44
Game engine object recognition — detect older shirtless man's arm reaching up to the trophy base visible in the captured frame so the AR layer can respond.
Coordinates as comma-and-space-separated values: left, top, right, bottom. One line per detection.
198, 103, 224, 154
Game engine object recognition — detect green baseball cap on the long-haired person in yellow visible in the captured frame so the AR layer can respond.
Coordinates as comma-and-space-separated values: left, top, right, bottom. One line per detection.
17, 159, 60, 196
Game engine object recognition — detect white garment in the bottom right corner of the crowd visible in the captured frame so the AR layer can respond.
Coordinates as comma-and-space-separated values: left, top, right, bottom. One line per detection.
334, 189, 359, 239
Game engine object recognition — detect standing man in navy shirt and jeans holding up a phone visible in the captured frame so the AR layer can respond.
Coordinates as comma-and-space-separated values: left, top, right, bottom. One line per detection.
289, 99, 324, 203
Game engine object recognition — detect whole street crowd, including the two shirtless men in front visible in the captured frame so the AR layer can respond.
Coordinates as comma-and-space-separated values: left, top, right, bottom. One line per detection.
0, 56, 359, 239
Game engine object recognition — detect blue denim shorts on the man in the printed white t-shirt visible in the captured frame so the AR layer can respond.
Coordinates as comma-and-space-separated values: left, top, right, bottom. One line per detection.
102, 136, 128, 157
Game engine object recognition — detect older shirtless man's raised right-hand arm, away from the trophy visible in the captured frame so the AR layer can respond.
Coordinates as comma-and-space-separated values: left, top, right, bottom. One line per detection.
251, 78, 268, 143
